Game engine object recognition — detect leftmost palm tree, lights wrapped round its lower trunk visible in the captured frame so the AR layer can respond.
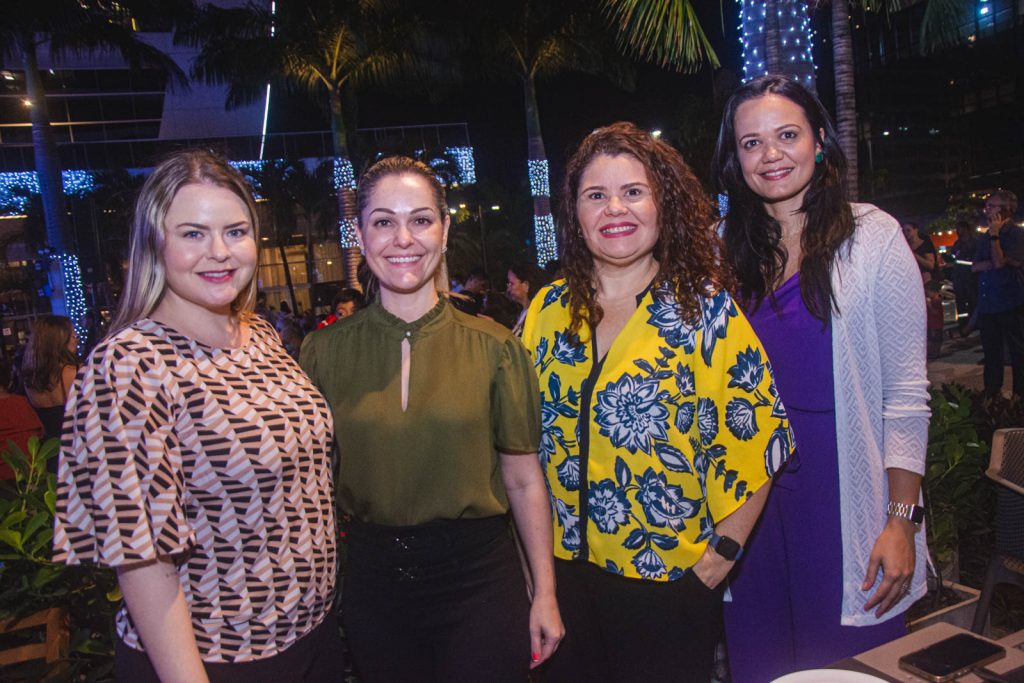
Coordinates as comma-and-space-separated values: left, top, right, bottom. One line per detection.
0, 0, 190, 313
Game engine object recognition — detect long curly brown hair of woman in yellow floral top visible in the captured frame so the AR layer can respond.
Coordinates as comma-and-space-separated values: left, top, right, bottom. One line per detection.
558, 121, 732, 334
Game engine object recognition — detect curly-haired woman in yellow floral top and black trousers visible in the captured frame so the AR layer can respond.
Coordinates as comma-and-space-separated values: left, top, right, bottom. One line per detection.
523, 123, 793, 681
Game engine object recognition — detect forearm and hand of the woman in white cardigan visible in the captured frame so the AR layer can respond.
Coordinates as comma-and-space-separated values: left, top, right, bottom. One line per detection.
860, 468, 921, 616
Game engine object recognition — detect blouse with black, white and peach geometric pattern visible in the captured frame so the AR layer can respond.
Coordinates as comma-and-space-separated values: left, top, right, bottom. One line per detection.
53, 316, 336, 663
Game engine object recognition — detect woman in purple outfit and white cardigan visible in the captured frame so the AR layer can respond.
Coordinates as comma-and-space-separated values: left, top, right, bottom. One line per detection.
713, 76, 929, 683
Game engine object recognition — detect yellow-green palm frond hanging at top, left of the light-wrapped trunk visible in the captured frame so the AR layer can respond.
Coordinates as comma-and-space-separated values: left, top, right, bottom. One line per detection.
603, 0, 720, 72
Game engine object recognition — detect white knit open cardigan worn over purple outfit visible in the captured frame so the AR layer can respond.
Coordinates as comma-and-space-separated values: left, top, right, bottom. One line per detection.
835, 204, 931, 626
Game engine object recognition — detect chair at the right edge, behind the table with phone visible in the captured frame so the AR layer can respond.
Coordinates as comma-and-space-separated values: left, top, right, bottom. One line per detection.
971, 429, 1024, 634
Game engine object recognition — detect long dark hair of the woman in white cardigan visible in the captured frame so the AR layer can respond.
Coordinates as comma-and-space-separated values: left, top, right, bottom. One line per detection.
712, 76, 854, 323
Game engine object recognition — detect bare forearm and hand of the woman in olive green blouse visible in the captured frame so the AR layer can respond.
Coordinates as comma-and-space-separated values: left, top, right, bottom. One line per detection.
501, 453, 565, 668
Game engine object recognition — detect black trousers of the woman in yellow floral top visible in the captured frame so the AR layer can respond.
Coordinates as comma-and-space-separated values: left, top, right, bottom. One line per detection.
541, 560, 724, 683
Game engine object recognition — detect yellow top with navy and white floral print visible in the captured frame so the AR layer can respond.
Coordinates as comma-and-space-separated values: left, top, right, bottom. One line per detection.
523, 281, 793, 581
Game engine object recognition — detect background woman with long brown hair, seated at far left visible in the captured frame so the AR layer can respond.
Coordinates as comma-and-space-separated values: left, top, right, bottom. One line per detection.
22, 315, 78, 444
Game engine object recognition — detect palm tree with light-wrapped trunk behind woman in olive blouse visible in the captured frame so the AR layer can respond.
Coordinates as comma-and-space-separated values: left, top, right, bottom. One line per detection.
181, 0, 449, 283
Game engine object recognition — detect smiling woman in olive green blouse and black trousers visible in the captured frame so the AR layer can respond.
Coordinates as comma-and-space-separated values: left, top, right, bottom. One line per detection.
300, 157, 563, 683
